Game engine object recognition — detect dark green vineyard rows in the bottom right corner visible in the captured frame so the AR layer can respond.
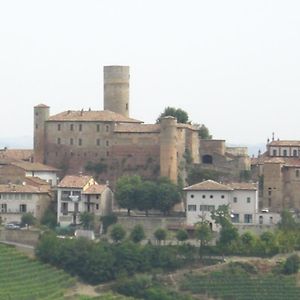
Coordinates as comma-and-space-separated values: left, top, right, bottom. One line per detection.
181, 267, 300, 300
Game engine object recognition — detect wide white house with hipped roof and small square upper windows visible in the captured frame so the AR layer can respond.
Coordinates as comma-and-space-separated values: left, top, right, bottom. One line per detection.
184, 180, 258, 231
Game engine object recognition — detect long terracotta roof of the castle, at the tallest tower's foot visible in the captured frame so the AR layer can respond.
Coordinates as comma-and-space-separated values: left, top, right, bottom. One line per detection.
47, 110, 143, 123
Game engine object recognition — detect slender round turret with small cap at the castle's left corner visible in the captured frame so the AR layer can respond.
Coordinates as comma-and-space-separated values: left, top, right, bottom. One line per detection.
33, 104, 50, 163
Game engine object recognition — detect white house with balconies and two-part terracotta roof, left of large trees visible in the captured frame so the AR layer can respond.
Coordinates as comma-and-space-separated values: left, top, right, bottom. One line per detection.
57, 175, 113, 226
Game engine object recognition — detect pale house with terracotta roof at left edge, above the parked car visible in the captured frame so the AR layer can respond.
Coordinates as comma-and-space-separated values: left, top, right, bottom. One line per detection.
0, 184, 51, 223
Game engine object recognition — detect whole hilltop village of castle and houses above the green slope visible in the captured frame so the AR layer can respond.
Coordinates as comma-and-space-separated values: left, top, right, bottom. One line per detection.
0, 66, 300, 234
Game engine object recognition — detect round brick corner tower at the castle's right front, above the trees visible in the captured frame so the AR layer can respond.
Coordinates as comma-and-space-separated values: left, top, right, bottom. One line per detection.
160, 116, 178, 183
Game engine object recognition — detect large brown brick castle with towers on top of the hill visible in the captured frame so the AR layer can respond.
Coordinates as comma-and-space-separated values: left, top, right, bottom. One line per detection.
34, 66, 250, 182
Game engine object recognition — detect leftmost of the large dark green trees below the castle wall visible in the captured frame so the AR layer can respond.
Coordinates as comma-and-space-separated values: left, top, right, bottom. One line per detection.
115, 175, 142, 215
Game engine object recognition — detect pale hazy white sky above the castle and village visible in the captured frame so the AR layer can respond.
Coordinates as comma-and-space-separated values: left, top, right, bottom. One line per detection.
0, 0, 300, 145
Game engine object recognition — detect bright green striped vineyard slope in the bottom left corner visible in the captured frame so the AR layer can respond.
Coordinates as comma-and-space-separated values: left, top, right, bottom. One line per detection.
0, 244, 75, 300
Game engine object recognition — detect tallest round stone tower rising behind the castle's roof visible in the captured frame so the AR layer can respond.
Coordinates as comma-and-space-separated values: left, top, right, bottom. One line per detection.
104, 66, 129, 117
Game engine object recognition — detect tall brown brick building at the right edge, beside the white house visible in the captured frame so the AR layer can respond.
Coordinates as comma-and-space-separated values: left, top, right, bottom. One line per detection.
252, 139, 300, 212
